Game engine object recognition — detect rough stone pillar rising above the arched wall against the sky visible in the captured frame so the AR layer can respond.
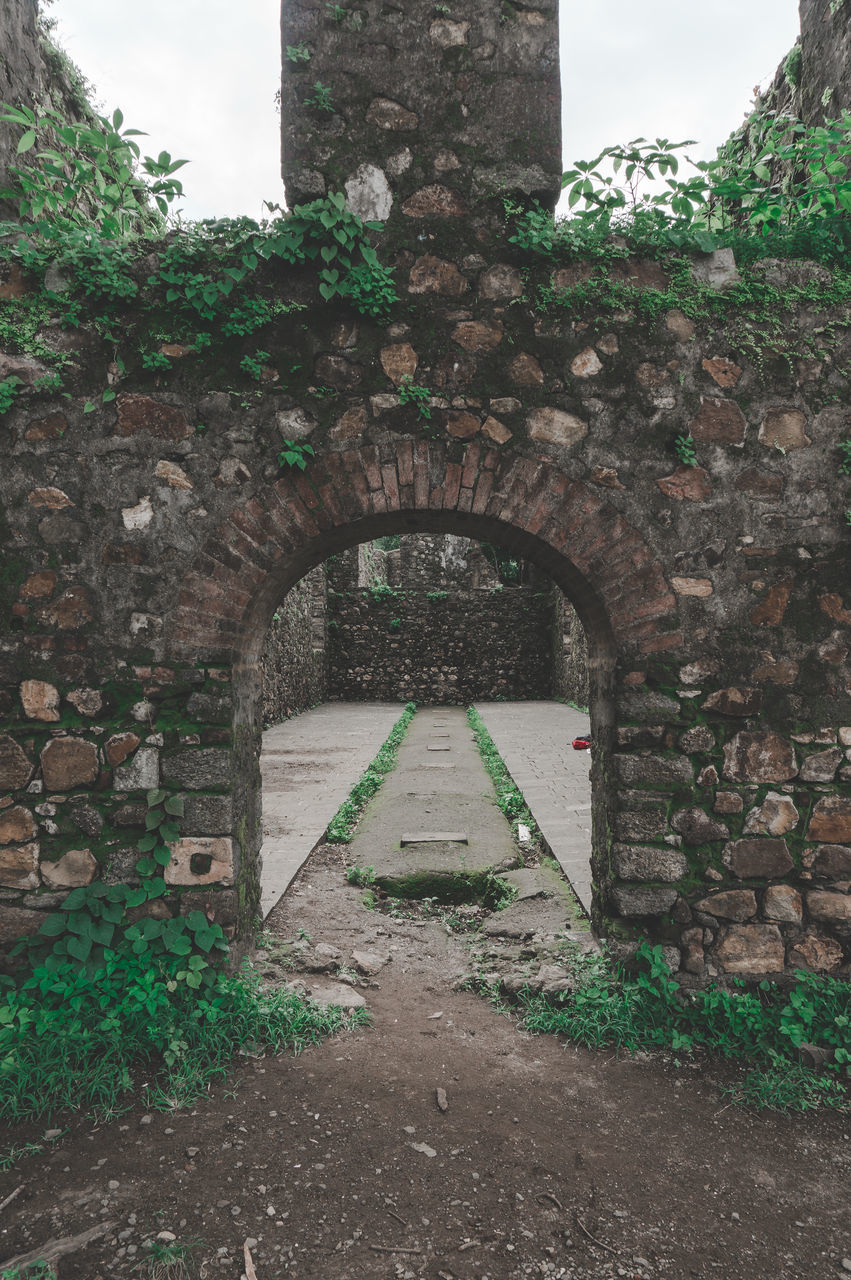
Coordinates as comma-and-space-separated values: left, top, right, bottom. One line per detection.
282, 0, 562, 232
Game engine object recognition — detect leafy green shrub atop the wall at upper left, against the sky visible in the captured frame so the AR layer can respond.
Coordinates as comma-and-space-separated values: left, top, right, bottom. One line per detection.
0, 104, 187, 239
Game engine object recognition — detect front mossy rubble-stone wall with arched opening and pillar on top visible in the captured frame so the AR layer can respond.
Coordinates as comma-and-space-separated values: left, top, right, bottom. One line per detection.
0, 0, 851, 980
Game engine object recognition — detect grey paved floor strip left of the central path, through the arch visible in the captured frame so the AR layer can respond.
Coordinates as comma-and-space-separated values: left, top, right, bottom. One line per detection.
260, 703, 402, 918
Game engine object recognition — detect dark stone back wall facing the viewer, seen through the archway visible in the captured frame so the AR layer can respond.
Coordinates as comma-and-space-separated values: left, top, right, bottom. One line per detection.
328, 586, 553, 705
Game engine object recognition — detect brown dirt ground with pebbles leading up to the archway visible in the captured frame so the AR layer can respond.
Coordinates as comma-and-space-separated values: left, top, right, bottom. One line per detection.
0, 846, 851, 1280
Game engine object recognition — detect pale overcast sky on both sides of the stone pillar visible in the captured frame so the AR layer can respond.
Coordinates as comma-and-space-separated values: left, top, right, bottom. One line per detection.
44, 0, 799, 218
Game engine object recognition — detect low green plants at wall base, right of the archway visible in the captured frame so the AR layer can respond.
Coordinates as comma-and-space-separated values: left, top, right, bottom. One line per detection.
521, 942, 851, 1110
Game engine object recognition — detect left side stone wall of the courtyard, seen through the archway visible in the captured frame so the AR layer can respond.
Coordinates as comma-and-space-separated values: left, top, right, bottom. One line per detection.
261, 566, 326, 724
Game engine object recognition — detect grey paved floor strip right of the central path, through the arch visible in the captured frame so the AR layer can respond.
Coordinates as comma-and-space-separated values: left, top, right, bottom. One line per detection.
476, 701, 591, 911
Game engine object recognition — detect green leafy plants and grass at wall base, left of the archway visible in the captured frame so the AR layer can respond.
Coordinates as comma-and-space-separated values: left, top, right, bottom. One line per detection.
0, 952, 357, 1120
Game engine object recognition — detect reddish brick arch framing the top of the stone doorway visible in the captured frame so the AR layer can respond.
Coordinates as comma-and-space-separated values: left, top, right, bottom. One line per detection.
166, 439, 682, 666
